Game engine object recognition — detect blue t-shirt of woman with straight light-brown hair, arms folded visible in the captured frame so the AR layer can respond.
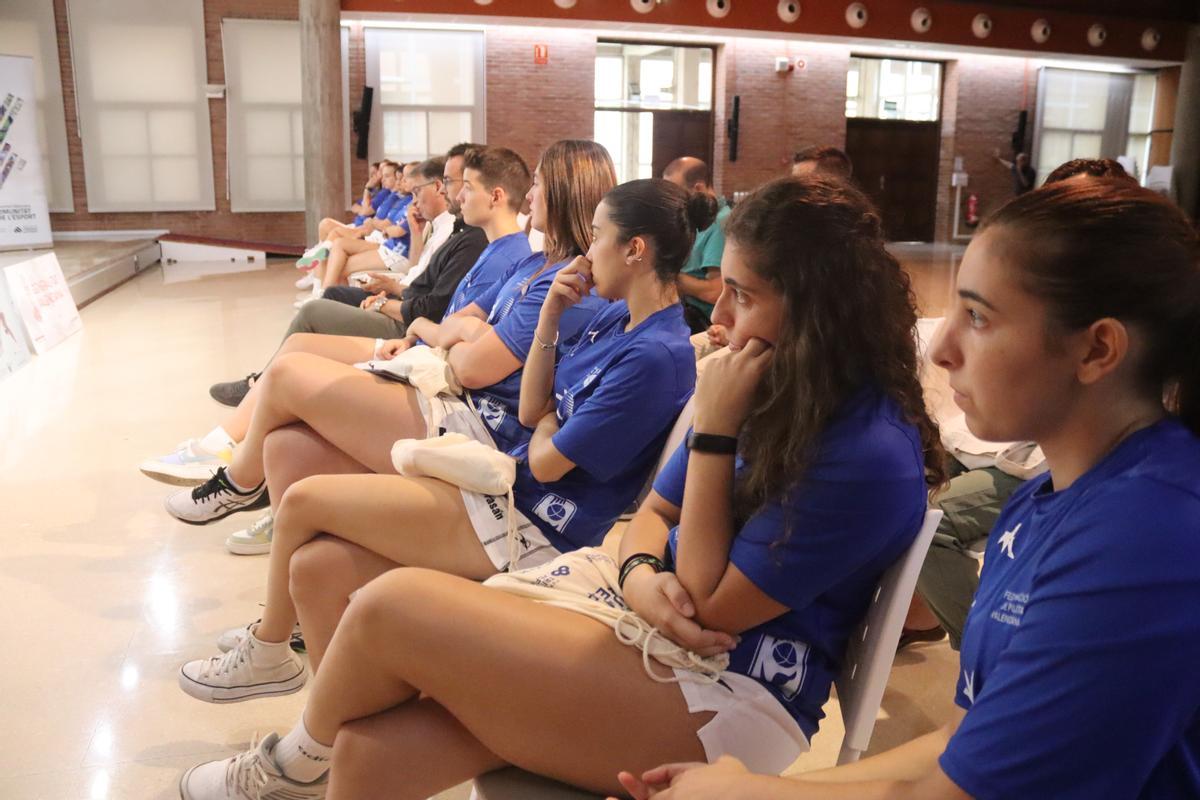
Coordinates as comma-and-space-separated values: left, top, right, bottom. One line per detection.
470, 252, 608, 452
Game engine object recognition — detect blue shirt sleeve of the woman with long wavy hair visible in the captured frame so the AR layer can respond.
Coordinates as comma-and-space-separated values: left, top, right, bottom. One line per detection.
730, 433, 924, 608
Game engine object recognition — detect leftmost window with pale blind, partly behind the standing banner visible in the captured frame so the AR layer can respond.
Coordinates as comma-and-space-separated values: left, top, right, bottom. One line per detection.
0, 0, 74, 211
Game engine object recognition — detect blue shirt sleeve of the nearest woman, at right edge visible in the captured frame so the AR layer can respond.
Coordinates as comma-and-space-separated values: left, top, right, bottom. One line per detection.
940, 485, 1200, 800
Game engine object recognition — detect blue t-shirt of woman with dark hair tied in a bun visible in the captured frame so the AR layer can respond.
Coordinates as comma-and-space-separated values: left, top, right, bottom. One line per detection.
511, 301, 696, 553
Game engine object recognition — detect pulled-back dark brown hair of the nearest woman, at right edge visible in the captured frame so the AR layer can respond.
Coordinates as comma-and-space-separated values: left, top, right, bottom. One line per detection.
979, 178, 1200, 435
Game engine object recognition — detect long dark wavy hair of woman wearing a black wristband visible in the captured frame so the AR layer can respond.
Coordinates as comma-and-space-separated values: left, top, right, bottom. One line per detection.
725, 175, 946, 515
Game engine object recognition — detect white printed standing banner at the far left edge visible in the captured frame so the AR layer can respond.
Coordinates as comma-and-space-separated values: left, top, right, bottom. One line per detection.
0, 55, 50, 249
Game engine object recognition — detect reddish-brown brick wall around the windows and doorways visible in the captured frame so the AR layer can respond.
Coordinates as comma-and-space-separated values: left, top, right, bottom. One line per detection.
52, 6, 1036, 245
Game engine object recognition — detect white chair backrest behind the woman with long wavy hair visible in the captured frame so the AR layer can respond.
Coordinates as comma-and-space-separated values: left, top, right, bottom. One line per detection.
835, 509, 942, 764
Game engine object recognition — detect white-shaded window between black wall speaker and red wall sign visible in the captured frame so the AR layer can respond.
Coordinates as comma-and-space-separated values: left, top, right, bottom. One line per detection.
366, 28, 484, 161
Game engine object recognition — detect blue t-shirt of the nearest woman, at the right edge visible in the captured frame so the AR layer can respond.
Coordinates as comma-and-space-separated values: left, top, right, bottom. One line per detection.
941, 419, 1200, 800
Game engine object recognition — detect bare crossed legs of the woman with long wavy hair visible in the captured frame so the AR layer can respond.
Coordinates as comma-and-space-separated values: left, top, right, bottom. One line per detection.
304, 570, 710, 800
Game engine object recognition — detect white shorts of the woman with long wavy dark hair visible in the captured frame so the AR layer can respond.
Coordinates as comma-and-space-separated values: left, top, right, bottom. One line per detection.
674, 669, 809, 775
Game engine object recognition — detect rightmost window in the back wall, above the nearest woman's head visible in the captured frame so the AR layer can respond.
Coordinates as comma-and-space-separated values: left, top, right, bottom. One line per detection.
1033, 67, 1156, 184
